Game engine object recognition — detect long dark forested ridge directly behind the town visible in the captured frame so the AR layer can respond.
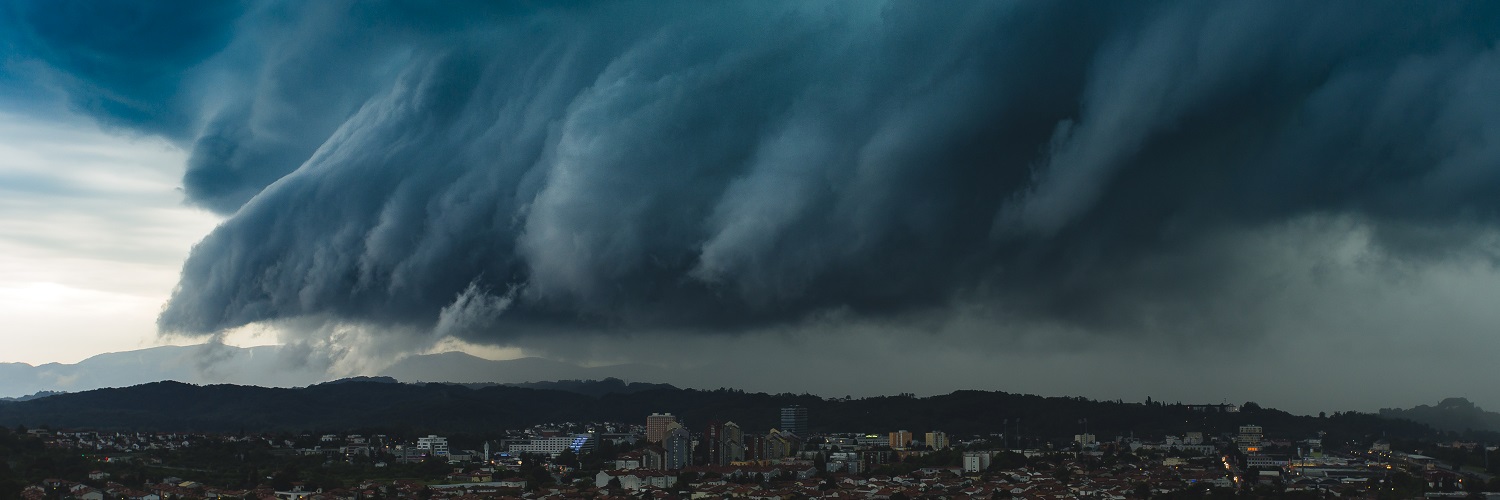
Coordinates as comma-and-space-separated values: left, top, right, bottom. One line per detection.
0, 381, 1476, 443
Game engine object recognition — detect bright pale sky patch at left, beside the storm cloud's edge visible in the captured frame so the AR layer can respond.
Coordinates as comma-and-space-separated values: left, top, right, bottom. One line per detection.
0, 114, 221, 365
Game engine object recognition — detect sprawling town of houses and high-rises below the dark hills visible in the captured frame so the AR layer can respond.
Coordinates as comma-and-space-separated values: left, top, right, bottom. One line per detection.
0, 405, 1500, 500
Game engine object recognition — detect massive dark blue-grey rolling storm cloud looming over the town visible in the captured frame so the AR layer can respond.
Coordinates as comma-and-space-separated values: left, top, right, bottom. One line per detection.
9, 2, 1500, 341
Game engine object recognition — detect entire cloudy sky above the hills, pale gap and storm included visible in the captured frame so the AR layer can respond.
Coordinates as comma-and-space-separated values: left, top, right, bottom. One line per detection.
0, 0, 1500, 411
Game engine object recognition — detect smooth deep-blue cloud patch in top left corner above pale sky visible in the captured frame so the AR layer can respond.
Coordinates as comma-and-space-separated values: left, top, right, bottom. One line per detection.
0, 0, 242, 137
